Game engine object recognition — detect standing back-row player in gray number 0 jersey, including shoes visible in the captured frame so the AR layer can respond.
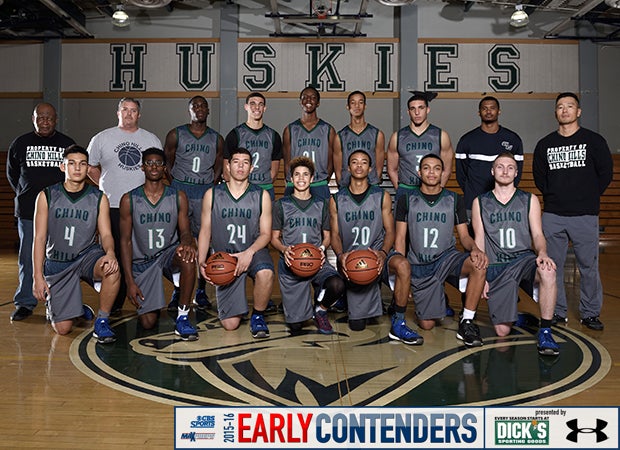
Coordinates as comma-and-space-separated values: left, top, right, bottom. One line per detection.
164, 95, 224, 311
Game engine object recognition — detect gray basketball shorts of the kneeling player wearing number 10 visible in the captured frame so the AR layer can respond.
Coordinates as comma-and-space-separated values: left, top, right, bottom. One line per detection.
487, 253, 537, 325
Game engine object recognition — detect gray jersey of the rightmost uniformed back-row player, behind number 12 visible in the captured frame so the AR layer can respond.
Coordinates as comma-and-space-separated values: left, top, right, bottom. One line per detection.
396, 125, 441, 186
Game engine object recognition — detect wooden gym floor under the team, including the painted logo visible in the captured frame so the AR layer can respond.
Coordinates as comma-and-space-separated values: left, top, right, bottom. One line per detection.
0, 248, 620, 449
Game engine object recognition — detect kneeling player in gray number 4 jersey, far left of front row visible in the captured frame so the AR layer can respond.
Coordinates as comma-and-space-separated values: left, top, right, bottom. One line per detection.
32, 145, 120, 344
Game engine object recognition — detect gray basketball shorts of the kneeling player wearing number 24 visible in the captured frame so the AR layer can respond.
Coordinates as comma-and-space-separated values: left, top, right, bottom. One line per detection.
215, 248, 274, 320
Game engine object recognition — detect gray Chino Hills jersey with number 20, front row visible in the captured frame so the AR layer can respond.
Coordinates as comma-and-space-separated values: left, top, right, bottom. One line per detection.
335, 185, 385, 252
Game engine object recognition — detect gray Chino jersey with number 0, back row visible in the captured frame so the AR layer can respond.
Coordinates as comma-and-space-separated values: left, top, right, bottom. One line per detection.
170, 125, 220, 184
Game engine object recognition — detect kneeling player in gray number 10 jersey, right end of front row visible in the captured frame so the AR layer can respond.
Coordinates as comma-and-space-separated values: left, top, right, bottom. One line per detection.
472, 152, 560, 356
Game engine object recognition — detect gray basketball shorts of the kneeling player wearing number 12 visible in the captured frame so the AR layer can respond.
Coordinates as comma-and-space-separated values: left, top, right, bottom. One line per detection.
411, 249, 469, 320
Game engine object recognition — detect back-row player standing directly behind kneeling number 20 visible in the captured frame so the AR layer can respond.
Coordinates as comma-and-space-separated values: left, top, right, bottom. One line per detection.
334, 91, 385, 188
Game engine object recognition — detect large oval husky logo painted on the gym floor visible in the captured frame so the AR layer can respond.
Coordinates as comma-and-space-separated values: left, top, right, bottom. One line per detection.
71, 312, 611, 406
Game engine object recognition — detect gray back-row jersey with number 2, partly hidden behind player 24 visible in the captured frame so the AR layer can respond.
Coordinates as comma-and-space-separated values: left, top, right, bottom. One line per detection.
235, 123, 276, 184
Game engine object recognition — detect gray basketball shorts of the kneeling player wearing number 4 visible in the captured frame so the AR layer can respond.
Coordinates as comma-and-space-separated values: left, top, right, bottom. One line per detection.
44, 244, 105, 323
